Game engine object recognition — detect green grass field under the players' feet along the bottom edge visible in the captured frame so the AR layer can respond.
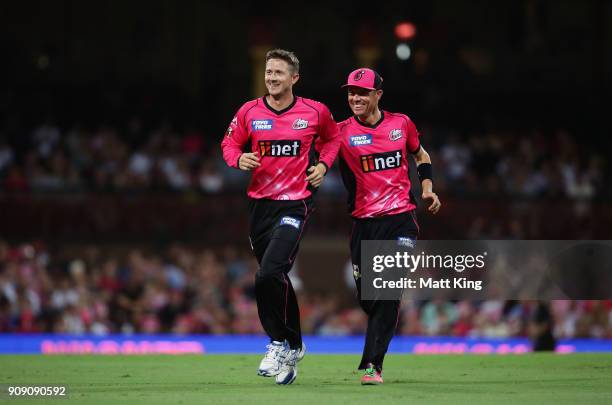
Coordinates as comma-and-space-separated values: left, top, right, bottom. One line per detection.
0, 354, 612, 405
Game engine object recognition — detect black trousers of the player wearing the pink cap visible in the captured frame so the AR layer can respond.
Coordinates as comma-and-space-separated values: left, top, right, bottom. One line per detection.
351, 210, 419, 371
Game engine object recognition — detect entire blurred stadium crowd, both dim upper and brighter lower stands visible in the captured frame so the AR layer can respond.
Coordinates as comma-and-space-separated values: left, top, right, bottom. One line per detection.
0, 117, 612, 337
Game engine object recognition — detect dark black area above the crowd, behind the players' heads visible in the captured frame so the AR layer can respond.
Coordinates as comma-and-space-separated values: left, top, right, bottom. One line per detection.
0, 0, 612, 138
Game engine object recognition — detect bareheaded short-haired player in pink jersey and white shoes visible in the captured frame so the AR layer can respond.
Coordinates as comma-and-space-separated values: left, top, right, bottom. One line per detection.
221, 49, 340, 384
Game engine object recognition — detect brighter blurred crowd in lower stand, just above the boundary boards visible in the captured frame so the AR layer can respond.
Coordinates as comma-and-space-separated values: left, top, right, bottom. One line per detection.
0, 241, 612, 338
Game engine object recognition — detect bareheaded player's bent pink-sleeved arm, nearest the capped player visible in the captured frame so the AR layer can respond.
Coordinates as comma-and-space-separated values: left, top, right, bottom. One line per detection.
306, 106, 340, 187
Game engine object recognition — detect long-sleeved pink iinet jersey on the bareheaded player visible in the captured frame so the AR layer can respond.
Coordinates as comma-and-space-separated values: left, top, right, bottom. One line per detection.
221, 97, 340, 200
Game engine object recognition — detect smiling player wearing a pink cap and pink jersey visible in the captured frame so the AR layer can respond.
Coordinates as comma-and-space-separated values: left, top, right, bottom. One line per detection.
338, 68, 441, 385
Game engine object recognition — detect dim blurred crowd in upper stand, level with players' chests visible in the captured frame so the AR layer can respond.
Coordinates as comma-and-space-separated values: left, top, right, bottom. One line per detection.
0, 117, 606, 199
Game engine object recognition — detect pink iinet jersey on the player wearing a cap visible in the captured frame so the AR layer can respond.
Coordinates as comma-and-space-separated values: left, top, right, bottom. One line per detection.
338, 111, 420, 218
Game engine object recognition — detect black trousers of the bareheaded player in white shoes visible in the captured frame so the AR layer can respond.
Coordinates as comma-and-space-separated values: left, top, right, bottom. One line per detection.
249, 197, 312, 349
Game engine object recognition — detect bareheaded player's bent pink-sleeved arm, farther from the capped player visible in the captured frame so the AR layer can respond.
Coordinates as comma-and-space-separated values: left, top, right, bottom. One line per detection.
221, 105, 260, 170
